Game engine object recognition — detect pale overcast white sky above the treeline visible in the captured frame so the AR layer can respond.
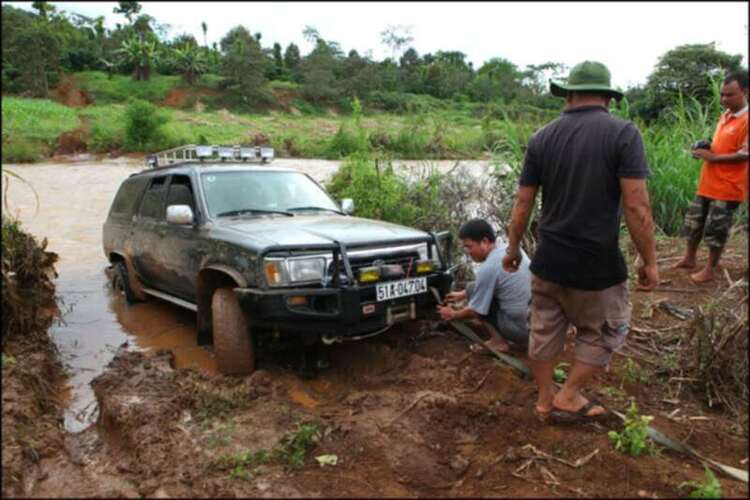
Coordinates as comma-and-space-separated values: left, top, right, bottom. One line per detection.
3, 2, 748, 89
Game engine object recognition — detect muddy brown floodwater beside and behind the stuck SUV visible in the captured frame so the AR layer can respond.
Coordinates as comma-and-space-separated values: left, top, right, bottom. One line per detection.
2, 156, 500, 432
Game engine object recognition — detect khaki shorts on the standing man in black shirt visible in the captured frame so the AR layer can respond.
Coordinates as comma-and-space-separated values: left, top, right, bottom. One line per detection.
529, 275, 630, 366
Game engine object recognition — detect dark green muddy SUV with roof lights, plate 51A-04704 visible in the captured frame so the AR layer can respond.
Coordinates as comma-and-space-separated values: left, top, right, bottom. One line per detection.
102, 146, 452, 374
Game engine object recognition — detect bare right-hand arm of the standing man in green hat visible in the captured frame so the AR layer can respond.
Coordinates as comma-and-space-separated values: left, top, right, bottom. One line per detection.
620, 177, 659, 290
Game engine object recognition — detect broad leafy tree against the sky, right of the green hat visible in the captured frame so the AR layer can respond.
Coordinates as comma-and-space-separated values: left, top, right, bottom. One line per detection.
639, 42, 742, 120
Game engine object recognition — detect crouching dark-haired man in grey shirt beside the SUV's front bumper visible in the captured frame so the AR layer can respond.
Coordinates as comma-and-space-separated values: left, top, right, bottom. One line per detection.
438, 219, 531, 352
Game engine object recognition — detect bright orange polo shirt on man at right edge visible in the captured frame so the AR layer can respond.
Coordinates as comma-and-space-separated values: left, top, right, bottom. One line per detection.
698, 106, 748, 202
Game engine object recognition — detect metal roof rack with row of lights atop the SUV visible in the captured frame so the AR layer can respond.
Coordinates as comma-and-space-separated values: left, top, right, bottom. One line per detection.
146, 144, 274, 168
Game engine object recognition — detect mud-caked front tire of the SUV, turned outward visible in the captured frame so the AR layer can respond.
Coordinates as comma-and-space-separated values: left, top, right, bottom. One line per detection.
211, 288, 255, 375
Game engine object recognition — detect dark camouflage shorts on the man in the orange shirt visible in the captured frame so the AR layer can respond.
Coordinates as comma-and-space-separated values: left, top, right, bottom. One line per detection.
684, 195, 740, 248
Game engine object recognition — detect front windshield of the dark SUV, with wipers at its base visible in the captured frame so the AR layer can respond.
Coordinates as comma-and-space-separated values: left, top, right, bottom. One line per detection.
201, 170, 341, 217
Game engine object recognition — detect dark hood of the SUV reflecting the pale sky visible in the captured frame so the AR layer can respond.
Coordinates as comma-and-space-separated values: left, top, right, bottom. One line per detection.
217, 215, 427, 246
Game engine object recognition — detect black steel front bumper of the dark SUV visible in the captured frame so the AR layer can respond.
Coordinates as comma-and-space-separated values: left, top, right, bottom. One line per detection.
234, 271, 453, 337
